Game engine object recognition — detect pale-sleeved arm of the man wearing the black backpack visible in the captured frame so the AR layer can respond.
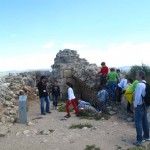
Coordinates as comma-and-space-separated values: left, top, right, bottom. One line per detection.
134, 84, 142, 108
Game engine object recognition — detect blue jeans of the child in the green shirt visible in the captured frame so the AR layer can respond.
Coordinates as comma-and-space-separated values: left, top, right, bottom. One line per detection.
106, 81, 117, 100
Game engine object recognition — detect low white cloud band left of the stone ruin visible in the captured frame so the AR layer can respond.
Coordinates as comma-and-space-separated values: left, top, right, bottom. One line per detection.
0, 52, 56, 71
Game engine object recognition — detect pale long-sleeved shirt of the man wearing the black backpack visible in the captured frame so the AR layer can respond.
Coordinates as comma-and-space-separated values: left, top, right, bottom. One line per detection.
134, 80, 146, 108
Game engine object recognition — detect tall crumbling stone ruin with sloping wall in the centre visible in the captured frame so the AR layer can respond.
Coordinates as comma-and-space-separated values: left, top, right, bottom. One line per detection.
52, 49, 99, 103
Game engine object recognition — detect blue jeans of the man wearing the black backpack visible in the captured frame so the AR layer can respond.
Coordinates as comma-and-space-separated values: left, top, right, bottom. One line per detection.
134, 104, 149, 141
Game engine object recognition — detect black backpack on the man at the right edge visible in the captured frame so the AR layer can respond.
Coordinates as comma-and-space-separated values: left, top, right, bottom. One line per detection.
142, 82, 150, 106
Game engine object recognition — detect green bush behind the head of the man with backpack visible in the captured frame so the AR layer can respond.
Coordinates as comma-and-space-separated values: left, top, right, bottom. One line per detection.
126, 64, 150, 83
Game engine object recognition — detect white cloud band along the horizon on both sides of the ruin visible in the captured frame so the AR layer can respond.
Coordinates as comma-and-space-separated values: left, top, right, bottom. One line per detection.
0, 42, 150, 71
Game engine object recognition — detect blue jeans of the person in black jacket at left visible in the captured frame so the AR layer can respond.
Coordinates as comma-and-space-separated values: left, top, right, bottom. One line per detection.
40, 96, 50, 113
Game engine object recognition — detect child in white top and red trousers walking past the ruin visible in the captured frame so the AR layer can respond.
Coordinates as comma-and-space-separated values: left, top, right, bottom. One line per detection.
65, 82, 78, 118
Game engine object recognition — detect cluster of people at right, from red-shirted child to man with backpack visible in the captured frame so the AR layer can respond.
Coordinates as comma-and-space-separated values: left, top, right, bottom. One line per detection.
98, 62, 150, 146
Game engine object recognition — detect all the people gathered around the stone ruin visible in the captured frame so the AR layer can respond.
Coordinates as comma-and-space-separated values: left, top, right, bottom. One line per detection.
37, 62, 150, 145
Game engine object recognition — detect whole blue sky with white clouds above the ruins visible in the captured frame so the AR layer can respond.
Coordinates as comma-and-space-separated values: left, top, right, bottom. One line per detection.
0, 0, 150, 71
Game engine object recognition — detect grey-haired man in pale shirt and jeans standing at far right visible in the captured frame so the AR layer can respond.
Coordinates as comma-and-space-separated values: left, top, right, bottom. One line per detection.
133, 70, 150, 146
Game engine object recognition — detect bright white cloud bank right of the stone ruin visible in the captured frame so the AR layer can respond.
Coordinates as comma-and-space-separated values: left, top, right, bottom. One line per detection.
79, 42, 150, 67
